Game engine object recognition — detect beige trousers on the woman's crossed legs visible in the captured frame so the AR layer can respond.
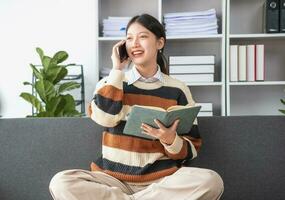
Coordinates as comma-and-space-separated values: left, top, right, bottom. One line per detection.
50, 167, 224, 200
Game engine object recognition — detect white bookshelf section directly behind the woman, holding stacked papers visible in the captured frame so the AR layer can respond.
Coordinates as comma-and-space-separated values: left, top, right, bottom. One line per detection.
96, 0, 226, 116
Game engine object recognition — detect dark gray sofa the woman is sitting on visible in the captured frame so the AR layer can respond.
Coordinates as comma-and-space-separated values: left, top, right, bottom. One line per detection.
0, 116, 285, 200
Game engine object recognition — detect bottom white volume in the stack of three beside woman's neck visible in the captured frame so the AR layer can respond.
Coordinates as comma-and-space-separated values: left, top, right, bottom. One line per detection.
170, 74, 214, 83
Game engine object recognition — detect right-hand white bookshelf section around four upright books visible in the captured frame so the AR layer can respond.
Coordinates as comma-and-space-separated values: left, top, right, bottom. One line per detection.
226, 0, 285, 115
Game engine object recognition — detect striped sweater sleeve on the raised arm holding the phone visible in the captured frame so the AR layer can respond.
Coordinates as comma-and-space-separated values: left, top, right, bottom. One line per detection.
90, 69, 125, 127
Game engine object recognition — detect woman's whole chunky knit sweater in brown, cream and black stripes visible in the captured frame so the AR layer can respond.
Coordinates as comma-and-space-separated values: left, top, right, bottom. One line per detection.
90, 70, 202, 182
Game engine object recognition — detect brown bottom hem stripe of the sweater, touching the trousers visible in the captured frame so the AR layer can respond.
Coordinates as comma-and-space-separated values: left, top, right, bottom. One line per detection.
91, 162, 178, 182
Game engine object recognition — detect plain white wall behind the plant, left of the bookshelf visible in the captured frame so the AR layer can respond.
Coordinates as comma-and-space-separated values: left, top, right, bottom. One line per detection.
0, 0, 97, 118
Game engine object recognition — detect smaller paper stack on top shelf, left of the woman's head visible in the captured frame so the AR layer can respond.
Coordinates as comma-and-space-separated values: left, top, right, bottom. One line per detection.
103, 16, 131, 37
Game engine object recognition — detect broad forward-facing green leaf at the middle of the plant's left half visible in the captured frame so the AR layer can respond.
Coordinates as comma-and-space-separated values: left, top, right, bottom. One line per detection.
35, 79, 56, 103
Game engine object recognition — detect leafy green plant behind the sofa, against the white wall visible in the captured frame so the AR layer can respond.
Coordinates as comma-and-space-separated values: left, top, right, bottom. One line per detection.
20, 48, 82, 117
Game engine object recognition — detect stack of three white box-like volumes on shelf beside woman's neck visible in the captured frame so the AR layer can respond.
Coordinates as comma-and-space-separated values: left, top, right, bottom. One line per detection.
169, 55, 215, 84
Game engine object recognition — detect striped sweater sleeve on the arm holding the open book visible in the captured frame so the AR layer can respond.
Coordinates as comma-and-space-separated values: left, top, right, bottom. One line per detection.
163, 84, 202, 160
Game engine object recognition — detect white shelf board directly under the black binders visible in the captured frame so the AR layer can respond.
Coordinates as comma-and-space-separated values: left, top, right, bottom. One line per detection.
230, 33, 285, 39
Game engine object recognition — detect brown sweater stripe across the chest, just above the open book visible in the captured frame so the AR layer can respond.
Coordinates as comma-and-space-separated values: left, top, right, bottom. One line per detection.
123, 94, 177, 109
